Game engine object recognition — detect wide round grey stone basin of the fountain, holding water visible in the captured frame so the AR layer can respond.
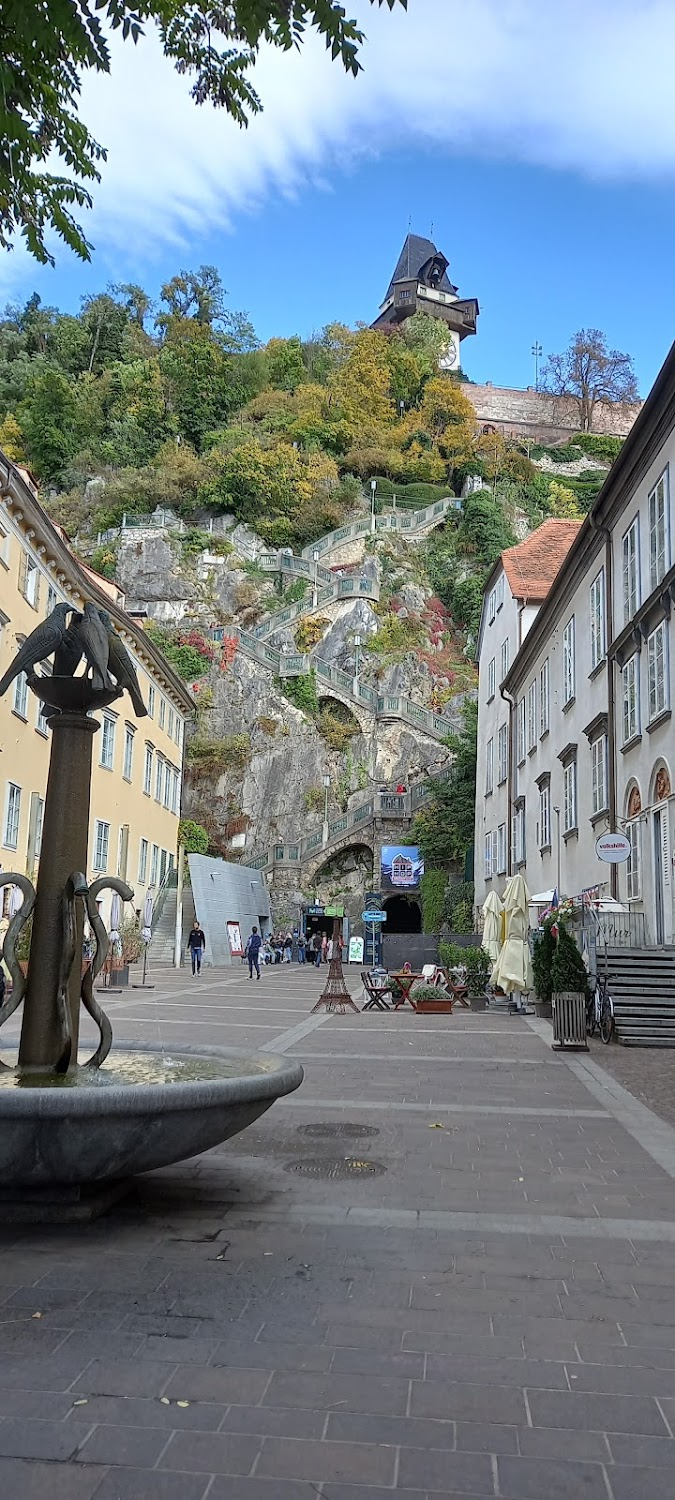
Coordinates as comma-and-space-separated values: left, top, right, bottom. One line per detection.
0, 1044, 303, 1193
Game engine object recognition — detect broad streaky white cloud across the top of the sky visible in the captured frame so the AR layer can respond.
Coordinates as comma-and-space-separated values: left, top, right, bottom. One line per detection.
1, 0, 675, 289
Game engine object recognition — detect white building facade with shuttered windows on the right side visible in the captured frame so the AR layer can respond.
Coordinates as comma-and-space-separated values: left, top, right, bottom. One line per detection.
476, 347, 675, 945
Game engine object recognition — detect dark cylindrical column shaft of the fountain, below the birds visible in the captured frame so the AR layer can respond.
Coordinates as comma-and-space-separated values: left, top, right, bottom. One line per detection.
18, 713, 99, 1070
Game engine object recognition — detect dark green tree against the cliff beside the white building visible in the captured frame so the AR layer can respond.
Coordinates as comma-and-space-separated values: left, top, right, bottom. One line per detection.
413, 698, 479, 866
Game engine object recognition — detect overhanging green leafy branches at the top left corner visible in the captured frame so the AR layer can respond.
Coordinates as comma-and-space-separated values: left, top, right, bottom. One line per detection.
0, 0, 407, 264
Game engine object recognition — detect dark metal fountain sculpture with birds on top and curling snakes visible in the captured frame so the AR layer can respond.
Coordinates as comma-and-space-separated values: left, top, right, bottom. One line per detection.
0, 591, 147, 1073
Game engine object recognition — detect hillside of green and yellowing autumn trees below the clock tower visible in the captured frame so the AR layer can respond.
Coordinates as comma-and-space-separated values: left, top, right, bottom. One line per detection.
0, 266, 614, 629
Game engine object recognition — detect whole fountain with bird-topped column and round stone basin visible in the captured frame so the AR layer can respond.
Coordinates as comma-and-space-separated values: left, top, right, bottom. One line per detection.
0, 603, 303, 1223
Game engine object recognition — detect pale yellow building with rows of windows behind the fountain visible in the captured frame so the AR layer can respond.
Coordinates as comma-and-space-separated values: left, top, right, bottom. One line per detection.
0, 455, 192, 926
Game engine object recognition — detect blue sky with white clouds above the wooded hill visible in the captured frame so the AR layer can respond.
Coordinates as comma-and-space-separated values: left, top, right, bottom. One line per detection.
0, 0, 675, 393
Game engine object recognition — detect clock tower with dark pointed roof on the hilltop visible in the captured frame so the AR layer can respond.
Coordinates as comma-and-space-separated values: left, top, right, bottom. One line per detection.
371, 234, 479, 371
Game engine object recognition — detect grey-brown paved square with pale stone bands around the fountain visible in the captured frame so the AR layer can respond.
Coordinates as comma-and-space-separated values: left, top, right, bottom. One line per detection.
0, 968, 675, 1500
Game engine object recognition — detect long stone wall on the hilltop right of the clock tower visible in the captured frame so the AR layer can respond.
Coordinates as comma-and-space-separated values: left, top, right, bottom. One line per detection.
462, 386, 642, 443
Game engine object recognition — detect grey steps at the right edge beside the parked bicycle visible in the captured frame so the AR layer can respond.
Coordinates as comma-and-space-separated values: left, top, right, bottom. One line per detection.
608, 948, 675, 1047
